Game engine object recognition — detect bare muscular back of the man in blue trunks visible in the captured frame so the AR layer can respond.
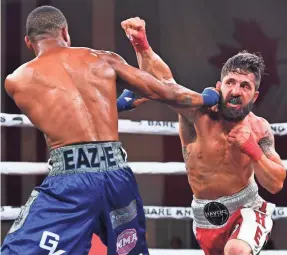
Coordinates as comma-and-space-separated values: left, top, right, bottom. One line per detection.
8, 48, 118, 148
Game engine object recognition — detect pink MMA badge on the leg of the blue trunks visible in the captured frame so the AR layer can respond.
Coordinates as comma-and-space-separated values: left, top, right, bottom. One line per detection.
117, 228, 138, 255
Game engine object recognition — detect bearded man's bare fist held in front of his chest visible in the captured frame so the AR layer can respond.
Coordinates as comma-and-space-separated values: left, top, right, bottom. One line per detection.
227, 125, 252, 148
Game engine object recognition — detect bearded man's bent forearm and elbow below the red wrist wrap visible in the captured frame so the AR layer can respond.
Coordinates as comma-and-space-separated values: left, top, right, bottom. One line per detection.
253, 154, 286, 194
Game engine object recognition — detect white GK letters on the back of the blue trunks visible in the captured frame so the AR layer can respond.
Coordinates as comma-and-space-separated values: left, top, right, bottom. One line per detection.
39, 231, 66, 255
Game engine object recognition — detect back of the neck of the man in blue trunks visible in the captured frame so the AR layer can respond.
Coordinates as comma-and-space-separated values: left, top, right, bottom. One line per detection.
32, 38, 68, 56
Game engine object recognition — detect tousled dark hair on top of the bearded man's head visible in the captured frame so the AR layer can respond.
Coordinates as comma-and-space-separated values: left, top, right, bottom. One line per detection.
221, 51, 265, 90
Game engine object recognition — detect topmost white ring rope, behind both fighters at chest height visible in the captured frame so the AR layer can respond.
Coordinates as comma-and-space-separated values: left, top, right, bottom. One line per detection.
0, 113, 287, 135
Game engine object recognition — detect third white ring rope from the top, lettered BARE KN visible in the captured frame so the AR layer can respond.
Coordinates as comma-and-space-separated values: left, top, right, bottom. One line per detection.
1, 206, 287, 220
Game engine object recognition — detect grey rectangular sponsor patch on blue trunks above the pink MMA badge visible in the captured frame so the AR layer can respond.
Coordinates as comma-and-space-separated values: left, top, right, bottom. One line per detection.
110, 200, 137, 229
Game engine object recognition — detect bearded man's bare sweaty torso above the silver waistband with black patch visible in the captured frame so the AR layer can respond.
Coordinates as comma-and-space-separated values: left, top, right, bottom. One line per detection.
179, 109, 266, 200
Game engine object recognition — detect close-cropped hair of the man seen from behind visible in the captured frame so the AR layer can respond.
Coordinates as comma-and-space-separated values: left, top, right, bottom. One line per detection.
26, 5, 68, 41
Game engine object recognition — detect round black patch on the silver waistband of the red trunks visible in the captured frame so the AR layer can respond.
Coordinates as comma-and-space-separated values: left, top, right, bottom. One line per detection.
203, 202, 229, 226
